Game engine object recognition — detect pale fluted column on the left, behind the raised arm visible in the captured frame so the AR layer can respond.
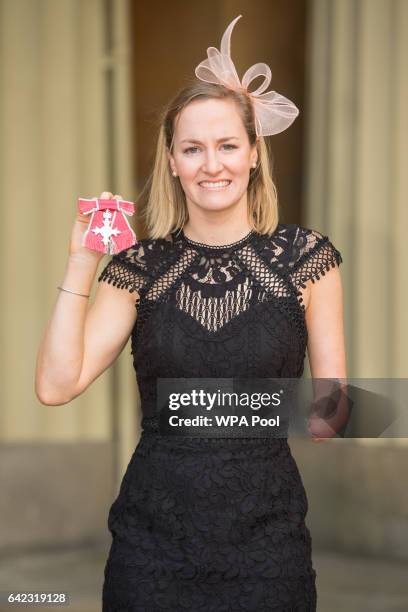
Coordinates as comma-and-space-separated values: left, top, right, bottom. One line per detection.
0, 0, 137, 498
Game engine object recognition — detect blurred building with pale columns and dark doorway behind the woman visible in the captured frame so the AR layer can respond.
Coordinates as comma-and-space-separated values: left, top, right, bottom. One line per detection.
0, 0, 408, 612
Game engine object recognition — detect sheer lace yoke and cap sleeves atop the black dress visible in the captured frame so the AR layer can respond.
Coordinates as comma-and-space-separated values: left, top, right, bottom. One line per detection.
98, 224, 342, 338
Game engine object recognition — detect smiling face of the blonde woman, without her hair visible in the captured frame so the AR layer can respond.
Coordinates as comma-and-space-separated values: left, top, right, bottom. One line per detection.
168, 98, 258, 216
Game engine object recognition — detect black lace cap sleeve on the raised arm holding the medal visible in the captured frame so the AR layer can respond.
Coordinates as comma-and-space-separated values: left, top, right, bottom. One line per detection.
98, 241, 149, 293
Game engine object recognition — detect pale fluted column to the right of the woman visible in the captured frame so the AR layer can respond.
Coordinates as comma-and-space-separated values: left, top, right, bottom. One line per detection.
305, 0, 408, 378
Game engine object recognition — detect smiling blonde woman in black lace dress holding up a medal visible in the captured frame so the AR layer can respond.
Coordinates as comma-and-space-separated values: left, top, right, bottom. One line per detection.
37, 14, 346, 612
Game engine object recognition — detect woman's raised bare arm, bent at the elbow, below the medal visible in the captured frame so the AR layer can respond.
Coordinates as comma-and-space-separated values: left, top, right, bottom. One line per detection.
35, 257, 138, 405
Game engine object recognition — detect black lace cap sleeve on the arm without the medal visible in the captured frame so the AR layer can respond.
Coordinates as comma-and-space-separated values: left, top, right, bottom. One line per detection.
291, 228, 343, 289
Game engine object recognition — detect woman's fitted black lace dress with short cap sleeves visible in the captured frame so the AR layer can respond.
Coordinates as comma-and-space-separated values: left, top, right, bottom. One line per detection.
98, 224, 342, 612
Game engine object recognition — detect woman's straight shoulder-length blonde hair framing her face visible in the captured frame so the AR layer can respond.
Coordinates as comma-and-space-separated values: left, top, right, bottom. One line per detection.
141, 79, 278, 238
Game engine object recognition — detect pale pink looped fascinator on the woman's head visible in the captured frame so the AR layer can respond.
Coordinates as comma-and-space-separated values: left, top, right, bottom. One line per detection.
195, 15, 299, 136
